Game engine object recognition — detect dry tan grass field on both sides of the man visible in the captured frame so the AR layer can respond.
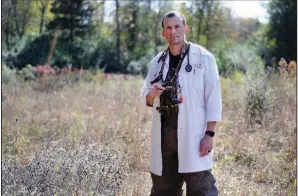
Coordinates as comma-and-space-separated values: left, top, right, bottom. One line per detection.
1, 71, 297, 196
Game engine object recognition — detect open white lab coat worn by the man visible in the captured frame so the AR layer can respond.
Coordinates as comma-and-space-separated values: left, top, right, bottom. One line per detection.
142, 43, 222, 176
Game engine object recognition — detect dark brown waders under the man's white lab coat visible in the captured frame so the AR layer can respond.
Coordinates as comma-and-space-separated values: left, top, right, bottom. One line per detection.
150, 117, 218, 196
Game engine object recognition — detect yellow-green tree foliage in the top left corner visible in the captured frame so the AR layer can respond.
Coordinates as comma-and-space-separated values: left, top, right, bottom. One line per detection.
1, 0, 53, 51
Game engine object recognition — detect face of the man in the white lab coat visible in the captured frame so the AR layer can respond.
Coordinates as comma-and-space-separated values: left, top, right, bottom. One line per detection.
162, 16, 188, 45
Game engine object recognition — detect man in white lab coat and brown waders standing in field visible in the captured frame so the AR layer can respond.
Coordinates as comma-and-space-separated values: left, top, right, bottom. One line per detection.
142, 11, 222, 196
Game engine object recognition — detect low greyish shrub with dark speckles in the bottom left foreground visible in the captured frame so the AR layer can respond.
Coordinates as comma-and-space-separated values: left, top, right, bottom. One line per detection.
2, 146, 127, 196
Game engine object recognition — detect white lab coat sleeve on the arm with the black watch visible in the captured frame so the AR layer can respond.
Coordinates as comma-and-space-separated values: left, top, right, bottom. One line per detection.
204, 55, 222, 122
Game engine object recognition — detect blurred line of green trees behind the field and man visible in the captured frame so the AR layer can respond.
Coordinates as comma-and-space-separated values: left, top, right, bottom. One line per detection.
1, 0, 297, 74
